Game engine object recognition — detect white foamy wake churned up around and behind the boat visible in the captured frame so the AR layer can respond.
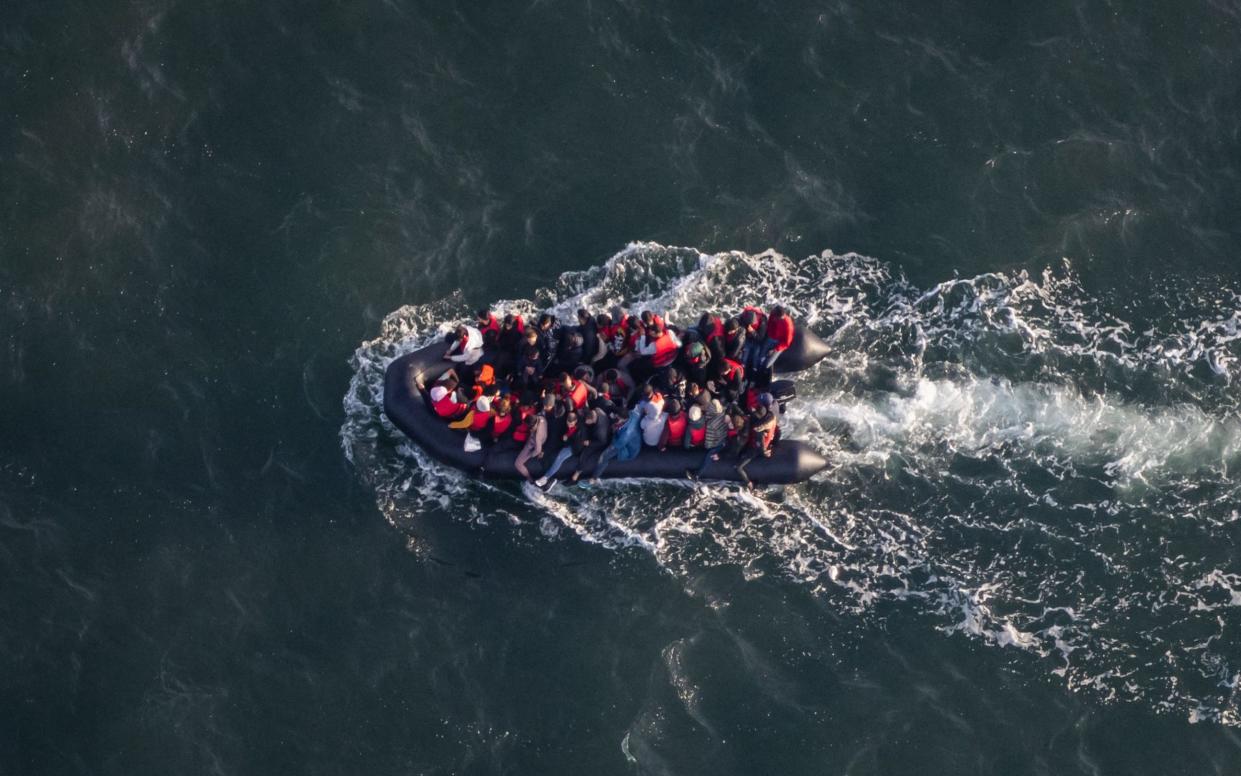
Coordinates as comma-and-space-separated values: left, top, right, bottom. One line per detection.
341, 243, 1241, 725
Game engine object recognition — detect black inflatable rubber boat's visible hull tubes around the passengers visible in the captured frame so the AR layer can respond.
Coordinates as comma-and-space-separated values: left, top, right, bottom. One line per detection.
383, 329, 828, 484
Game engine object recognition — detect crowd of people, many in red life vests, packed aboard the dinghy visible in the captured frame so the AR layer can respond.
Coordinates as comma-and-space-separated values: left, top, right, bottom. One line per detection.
419, 305, 794, 488
